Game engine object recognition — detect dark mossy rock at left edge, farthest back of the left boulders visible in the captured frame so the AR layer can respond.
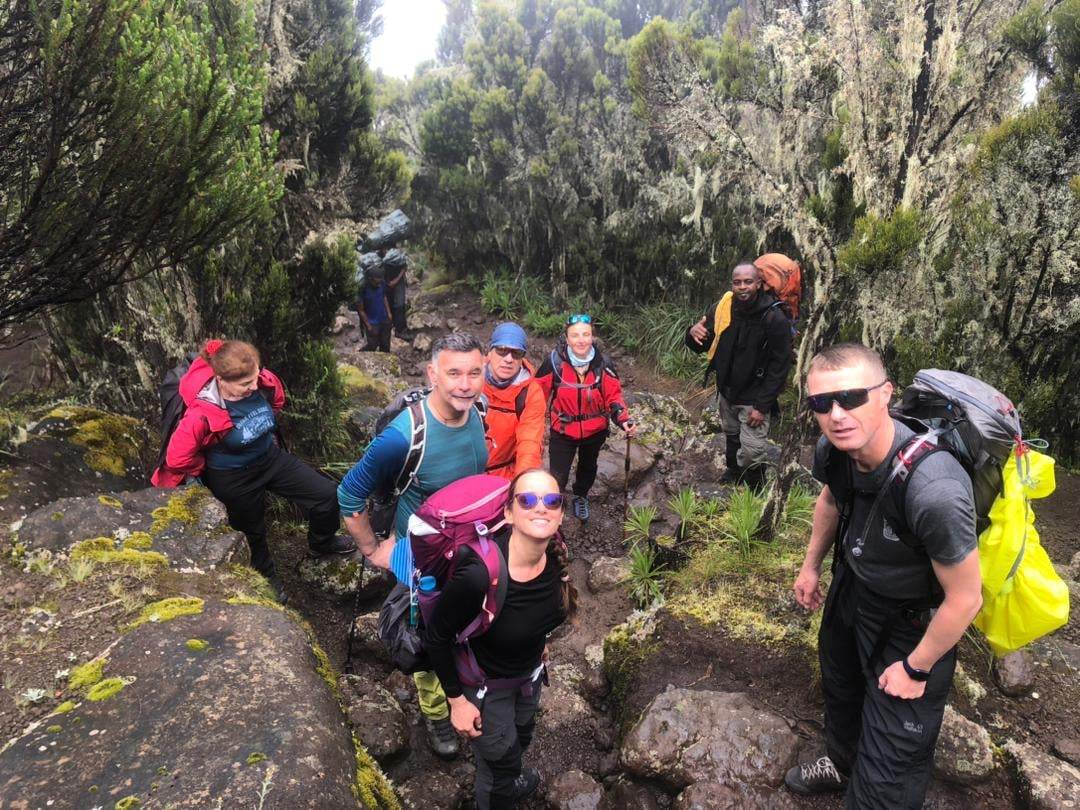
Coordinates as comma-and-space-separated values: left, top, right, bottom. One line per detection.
0, 405, 150, 525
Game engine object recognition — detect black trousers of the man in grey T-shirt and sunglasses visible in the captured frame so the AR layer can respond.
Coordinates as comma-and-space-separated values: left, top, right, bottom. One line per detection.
818, 564, 956, 810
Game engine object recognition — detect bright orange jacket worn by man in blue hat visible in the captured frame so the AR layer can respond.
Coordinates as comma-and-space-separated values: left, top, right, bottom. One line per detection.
484, 360, 546, 478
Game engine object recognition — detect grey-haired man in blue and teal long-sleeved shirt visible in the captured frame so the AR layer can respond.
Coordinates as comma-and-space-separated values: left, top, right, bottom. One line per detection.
337, 333, 487, 758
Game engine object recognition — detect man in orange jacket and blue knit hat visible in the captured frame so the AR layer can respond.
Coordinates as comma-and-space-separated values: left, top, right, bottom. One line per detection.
484, 323, 548, 478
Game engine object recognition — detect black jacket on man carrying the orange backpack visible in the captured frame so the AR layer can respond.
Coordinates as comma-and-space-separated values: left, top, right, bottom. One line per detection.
686, 289, 792, 414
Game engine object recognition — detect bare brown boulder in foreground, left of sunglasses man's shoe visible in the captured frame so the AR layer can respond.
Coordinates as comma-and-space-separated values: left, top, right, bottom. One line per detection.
620, 686, 799, 789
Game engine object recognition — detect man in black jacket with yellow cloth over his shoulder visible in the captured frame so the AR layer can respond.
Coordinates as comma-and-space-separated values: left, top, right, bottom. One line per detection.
686, 261, 792, 487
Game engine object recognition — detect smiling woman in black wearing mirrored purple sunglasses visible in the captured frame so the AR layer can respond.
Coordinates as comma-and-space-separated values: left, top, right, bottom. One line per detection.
424, 470, 578, 810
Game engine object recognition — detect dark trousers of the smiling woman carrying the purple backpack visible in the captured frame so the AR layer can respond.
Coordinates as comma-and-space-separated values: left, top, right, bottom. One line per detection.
462, 677, 542, 810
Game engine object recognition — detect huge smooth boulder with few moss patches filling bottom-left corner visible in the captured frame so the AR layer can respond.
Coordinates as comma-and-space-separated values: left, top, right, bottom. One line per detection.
0, 599, 356, 808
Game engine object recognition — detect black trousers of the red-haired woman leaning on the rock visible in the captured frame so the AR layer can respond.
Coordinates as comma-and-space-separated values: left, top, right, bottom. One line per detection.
200, 445, 341, 576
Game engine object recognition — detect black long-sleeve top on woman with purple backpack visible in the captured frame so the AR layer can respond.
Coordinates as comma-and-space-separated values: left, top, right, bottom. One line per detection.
423, 527, 566, 698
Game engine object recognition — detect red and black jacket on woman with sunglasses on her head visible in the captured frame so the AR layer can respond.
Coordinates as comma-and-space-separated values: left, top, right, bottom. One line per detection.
537, 342, 630, 440
